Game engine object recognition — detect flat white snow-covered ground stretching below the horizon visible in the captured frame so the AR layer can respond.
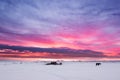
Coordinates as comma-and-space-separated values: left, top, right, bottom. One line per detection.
0, 61, 120, 80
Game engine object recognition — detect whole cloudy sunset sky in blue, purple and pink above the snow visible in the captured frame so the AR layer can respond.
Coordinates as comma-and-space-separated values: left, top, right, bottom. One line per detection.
0, 0, 120, 59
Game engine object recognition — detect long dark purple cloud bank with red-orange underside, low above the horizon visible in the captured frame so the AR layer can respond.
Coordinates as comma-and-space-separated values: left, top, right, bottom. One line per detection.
0, 45, 107, 58
